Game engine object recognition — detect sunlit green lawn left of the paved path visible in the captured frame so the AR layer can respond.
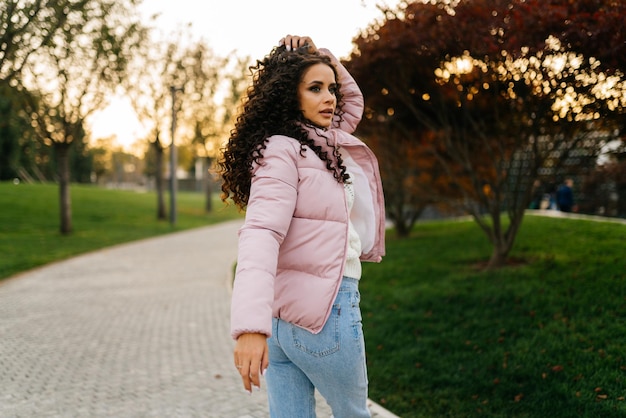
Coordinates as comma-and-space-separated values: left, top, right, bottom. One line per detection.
0, 182, 242, 279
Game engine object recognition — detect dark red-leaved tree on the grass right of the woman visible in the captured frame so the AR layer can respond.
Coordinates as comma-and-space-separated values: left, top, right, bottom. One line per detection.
346, 0, 626, 268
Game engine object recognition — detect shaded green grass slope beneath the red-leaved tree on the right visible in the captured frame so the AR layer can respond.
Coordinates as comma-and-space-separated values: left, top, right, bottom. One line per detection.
361, 217, 626, 418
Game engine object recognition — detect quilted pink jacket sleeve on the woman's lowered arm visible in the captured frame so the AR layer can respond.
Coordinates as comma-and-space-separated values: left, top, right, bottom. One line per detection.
231, 137, 298, 339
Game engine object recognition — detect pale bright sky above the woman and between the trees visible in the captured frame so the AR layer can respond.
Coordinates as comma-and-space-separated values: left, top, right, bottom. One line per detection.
91, 0, 399, 148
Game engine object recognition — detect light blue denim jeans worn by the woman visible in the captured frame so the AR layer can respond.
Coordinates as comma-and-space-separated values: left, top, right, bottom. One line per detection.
265, 277, 371, 418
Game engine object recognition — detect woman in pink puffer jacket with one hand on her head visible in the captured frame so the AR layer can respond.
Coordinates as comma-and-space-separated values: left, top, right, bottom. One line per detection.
220, 35, 385, 418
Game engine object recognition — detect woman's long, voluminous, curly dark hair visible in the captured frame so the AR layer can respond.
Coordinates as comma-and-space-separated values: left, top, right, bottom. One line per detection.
218, 46, 348, 209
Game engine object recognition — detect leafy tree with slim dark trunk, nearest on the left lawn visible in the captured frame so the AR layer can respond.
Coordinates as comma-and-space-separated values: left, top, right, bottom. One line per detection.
21, 0, 145, 234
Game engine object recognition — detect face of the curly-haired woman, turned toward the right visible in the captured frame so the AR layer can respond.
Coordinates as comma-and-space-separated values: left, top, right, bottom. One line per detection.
298, 63, 337, 128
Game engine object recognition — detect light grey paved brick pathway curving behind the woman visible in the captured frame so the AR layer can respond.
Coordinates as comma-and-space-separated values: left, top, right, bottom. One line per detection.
0, 221, 395, 418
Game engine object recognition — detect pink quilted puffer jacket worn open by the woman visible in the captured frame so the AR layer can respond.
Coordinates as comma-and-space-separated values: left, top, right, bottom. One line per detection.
231, 50, 385, 339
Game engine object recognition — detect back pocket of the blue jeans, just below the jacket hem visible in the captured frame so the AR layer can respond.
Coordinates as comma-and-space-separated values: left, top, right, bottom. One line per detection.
291, 303, 341, 357
